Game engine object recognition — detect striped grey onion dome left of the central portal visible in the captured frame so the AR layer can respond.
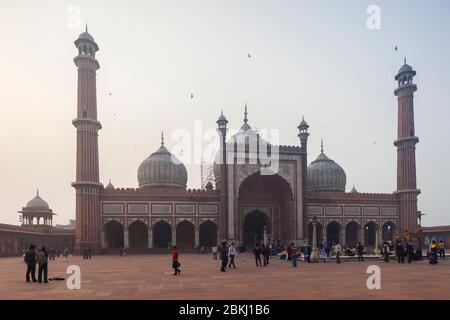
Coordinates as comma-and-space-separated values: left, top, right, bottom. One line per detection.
138, 136, 187, 188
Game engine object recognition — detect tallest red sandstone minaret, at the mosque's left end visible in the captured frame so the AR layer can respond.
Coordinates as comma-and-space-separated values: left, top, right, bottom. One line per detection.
72, 26, 103, 253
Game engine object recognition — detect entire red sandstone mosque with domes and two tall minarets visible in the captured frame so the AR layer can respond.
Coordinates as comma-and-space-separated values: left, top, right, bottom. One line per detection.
0, 30, 450, 255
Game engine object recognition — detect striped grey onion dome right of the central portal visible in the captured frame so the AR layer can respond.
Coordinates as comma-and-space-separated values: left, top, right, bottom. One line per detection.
308, 143, 347, 192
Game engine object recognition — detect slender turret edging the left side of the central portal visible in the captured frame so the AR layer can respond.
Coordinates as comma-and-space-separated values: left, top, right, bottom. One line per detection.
216, 111, 228, 241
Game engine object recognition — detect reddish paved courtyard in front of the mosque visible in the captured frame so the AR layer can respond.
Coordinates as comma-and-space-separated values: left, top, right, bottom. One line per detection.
0, 254, 450, 300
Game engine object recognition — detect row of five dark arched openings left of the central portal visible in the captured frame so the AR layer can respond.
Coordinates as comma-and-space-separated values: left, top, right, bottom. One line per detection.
103, 220, 217, 250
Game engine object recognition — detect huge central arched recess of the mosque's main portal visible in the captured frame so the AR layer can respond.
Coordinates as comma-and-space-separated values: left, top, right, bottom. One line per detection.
236, 172, 296, 242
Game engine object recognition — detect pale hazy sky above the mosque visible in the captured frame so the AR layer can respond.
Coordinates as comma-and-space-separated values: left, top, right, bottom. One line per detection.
0, 0, 450, 226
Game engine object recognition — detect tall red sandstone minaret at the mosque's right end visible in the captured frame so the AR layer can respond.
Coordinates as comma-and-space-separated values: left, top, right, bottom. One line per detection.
394, 58, 420, 233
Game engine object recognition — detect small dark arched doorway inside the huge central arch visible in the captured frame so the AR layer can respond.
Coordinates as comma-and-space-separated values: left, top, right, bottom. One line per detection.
244, 210, 270, 247
